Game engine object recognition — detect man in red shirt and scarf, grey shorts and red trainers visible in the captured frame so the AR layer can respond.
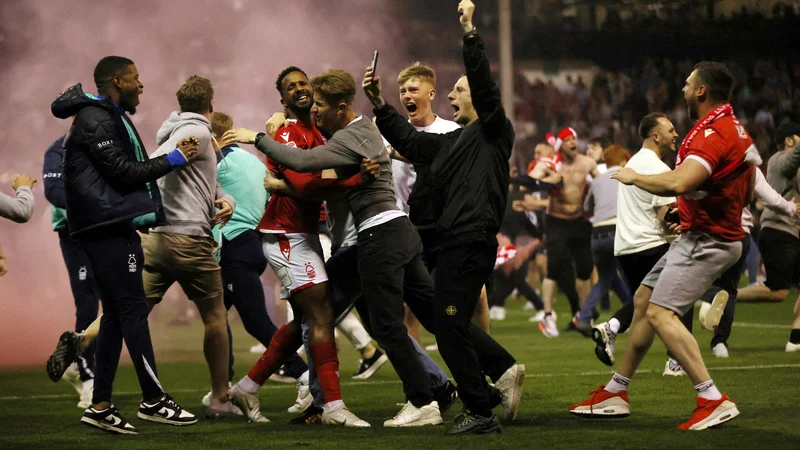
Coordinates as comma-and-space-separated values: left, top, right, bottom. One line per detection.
570, 62, 755, 430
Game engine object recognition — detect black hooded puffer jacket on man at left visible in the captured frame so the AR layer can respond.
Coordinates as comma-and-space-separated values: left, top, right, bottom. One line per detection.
50, 84, 172, 236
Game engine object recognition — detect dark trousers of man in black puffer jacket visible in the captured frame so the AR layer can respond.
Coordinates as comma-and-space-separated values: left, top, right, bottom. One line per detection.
80, 224, 163, 403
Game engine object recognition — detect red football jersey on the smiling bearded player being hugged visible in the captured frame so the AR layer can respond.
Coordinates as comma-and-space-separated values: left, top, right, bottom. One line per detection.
256, 120, 325, 234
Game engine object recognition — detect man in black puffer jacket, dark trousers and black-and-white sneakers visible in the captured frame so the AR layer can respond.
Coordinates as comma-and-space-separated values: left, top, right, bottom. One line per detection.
47, 56, 198, 434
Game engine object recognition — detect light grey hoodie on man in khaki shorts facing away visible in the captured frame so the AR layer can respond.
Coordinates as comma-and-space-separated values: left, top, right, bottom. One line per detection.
150, 112, 236, 237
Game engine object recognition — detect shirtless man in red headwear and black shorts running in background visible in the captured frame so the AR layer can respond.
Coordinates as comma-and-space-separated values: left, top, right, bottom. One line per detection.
530, 128, 600, 337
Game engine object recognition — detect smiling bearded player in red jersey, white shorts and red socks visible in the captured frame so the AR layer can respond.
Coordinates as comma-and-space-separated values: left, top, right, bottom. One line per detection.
230, 67, 369, 427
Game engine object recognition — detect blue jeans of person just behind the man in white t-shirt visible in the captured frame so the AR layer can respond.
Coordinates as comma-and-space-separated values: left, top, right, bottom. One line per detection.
580, 231, 633, 323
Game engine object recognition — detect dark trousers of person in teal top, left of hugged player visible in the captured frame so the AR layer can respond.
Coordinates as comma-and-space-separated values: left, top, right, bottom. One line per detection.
219, 230, 308, 380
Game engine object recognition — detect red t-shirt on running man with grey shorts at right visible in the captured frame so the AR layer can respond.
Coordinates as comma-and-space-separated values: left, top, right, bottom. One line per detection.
678, 116, 753, 241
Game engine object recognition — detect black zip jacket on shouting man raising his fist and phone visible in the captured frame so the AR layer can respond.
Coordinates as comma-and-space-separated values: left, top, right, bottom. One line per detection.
375, 34, 514, 248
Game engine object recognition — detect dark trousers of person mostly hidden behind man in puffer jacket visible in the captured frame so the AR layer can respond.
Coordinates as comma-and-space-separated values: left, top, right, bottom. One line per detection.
59, 231, 100, 381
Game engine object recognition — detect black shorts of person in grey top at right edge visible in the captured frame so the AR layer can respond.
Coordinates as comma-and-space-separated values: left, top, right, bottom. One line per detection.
758, 228, 800, 291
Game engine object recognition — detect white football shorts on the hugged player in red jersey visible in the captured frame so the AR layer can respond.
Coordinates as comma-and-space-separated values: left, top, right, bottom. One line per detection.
261, 233, 328, 300
